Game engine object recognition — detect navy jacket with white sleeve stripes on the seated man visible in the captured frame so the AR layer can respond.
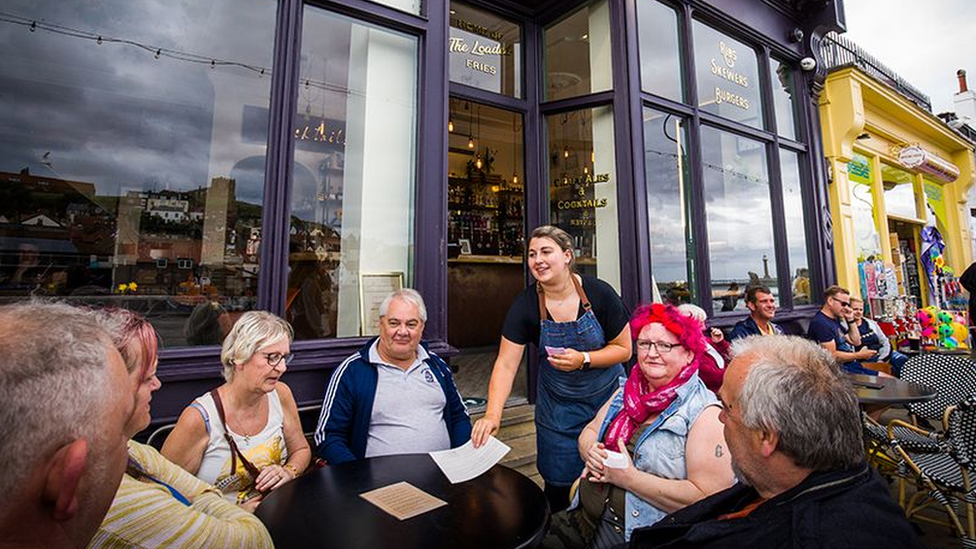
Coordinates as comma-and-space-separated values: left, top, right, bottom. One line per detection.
315, 337, 471, 465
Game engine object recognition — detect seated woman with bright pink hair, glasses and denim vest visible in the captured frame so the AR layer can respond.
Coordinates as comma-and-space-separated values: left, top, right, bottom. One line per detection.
543, 303, 733, 547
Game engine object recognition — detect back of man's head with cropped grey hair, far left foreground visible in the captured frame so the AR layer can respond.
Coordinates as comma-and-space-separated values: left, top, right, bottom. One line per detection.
0, 302, 135, 549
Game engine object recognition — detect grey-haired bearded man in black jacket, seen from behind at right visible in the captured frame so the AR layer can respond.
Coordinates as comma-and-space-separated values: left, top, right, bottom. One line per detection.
631, 335, 921, 549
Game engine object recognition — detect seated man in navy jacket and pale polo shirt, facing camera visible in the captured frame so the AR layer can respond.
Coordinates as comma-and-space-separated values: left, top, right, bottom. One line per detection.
315, 289, 471, 465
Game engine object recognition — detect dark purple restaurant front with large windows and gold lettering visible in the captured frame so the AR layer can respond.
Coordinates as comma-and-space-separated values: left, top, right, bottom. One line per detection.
0, 0, 844, 422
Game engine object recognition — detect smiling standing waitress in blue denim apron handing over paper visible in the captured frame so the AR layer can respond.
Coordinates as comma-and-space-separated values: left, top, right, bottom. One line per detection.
471, 225, 632, 512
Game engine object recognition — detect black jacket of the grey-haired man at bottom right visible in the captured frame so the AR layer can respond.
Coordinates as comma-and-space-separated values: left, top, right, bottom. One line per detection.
630, 464, 922, 549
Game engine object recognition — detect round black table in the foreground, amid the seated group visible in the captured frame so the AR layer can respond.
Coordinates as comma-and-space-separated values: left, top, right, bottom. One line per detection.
256, 454, 549, 549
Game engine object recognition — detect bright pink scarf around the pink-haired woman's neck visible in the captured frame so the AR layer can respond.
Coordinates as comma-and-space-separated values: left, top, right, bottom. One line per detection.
603, 356, 699, 452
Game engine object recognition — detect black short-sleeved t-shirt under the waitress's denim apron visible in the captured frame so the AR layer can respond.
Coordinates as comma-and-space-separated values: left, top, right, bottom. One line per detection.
502, 276, 630, 345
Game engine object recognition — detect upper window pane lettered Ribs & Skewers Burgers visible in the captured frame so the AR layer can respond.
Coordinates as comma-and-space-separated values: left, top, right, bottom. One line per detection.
693, 21, 763, 128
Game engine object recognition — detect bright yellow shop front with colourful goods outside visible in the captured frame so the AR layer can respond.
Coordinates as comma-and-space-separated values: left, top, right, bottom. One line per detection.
821, 55, 974, 343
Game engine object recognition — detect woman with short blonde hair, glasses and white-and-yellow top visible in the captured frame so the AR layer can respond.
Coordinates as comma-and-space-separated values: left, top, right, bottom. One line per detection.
162, 311, 312, 510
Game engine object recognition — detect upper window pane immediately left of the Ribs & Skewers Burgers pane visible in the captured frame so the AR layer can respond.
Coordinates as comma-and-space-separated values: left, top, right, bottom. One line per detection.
637, 0, 682, 101
